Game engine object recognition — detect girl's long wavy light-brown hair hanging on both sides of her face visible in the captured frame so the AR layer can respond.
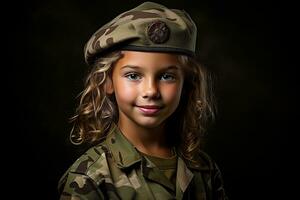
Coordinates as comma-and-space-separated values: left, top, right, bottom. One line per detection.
70, 51, 215, 162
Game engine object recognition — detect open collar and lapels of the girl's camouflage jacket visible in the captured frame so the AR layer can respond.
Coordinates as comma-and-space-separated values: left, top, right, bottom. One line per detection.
105, 124, 214, 195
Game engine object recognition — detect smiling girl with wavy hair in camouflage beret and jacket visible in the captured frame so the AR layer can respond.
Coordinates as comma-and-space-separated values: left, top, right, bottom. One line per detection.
59, 2, 226, 200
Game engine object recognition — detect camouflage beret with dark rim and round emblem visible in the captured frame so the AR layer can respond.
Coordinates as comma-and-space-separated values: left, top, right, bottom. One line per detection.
84, 2, 197, 64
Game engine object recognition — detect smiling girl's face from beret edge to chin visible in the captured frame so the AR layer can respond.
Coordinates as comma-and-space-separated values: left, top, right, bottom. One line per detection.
111, 51, 184, 128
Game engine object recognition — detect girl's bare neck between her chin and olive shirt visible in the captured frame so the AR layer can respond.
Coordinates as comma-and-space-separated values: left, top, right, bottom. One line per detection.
118, 121, 172, 157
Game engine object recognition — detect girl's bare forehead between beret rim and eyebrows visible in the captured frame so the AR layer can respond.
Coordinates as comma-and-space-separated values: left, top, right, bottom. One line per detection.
116, 51, 180, 68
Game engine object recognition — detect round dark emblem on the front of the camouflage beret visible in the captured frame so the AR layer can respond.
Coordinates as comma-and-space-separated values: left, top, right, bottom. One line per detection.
147, 21, 170, 44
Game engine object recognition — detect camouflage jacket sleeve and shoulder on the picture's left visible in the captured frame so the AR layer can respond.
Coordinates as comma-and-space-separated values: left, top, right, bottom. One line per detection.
58, 172, 104, 200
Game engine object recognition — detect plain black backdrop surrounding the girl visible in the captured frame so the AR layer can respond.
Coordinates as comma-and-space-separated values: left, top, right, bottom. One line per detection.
2, 0, 284, 199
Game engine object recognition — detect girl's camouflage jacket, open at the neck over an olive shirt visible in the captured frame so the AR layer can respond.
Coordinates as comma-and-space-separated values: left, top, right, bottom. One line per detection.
59, 125, 227, 200
